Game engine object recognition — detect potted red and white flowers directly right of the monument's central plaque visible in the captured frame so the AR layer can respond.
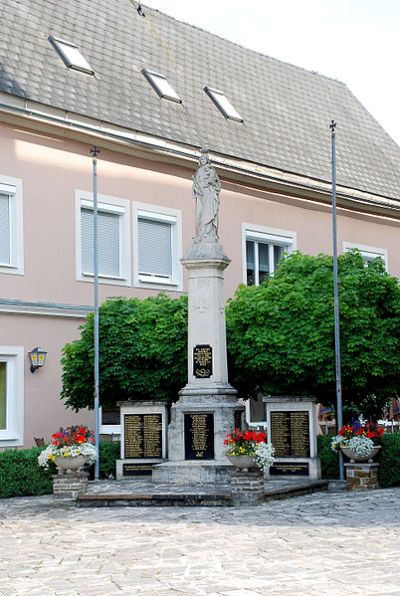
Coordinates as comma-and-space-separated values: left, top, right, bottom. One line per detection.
224, 428, 275, 469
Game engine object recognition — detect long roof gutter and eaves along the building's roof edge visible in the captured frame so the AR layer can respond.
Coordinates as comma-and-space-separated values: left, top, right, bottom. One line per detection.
0, 98, 400, 219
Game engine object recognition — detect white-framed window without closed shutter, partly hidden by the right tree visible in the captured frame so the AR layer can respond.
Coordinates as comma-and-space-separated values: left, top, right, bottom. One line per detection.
242, 224, 296, 286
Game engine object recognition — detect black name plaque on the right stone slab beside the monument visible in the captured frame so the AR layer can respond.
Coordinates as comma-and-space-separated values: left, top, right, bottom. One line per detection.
270, 411, 310, 457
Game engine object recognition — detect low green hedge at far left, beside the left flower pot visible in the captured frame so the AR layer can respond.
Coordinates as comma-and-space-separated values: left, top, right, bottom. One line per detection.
0, 447, 54, 498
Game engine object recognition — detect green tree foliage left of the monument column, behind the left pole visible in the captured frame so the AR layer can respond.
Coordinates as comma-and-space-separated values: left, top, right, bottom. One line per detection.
61, 294, 187, 411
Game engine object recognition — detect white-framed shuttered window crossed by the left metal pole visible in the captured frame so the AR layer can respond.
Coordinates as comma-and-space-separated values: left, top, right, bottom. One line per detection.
75, 191, 131, 285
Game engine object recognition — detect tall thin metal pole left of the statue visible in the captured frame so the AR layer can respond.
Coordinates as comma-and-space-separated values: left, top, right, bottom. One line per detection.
90, 146, 100, 480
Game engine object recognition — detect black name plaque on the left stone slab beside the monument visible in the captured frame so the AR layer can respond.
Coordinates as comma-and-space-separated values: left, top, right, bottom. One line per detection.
124, 413, 162, 459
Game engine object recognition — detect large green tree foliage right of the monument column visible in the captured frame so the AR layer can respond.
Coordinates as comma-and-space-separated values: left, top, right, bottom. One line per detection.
227, 251, 400, 417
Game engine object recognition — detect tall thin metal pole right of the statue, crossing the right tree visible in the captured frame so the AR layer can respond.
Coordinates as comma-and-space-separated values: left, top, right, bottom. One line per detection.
330, 120, 344, 480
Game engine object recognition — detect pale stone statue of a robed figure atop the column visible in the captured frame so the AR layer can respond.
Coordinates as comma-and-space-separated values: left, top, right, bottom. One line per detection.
193, 148, 221, 243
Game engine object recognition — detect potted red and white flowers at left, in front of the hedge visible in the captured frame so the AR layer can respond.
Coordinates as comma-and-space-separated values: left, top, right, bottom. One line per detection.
38, 425, 97, 472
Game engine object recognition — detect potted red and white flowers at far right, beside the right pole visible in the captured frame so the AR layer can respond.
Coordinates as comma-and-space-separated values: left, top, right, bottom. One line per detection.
331, 417, 384, 462
